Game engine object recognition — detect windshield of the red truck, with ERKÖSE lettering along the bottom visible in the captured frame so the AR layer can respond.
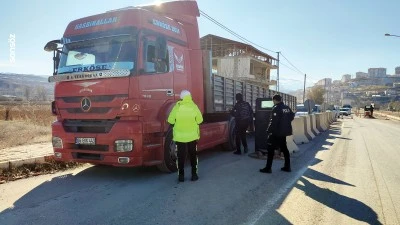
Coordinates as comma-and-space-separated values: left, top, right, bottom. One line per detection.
58, 35, 137, 74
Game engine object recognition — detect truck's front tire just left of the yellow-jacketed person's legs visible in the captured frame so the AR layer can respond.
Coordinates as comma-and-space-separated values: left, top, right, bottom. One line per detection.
157, 129, 178, 173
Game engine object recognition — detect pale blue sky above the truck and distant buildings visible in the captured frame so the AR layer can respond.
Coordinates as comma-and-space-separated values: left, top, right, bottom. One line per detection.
0, 0, 400, 90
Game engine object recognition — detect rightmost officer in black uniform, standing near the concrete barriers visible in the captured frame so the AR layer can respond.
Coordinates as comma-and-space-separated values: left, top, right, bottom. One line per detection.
260, 95, 294, 173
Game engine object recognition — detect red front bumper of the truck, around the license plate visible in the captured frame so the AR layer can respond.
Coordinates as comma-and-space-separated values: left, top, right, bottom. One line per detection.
52, 121, 143, 167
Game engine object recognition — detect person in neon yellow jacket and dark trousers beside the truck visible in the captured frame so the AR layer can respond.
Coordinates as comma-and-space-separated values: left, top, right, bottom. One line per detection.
168, 90, 203, 182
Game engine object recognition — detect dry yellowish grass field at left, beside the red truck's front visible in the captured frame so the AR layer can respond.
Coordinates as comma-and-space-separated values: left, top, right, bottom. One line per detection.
0, 105, 55, 149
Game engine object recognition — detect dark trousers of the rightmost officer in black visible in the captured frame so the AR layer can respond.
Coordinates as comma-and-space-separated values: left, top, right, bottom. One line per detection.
266, 135, 290, 169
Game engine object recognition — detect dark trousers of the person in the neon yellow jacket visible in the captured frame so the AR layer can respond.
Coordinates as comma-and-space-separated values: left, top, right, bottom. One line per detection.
176, 141, 198, 176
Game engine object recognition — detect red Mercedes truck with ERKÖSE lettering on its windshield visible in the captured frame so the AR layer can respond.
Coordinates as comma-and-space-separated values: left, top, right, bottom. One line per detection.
44, 1, 295, 172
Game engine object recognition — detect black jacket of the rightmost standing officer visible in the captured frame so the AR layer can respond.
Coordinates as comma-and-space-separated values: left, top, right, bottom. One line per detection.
267, 102, 294, 137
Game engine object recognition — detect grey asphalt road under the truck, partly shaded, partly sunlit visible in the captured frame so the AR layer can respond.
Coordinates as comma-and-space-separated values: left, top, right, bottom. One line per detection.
0, 118, 400, 225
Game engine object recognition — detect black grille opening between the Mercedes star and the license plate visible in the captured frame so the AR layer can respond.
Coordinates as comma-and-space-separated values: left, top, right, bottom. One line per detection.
63, 120, 117, 134
